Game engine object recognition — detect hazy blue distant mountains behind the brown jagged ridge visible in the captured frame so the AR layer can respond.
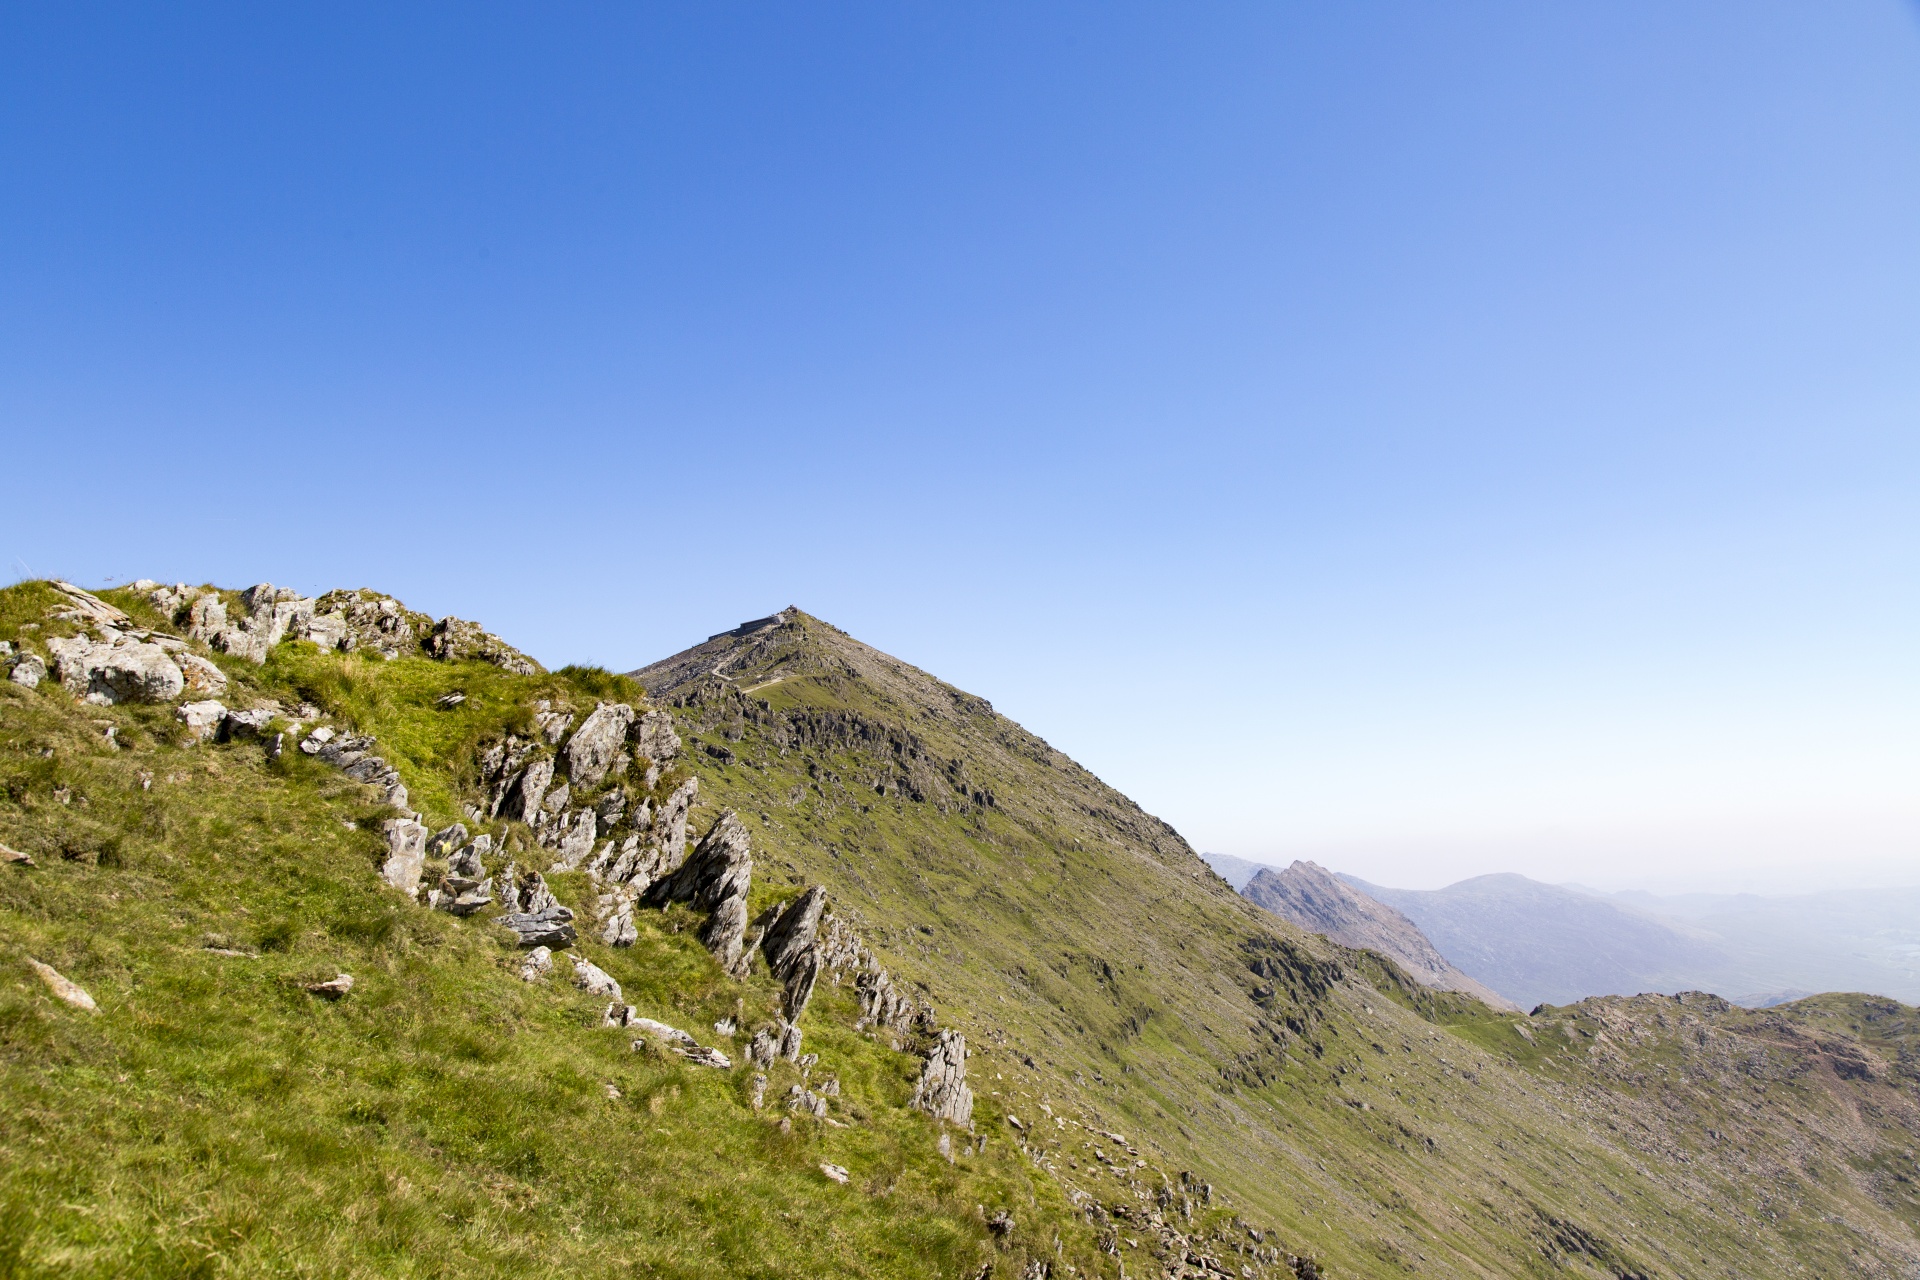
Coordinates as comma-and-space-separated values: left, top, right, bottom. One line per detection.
1208, 856, 1920, 1007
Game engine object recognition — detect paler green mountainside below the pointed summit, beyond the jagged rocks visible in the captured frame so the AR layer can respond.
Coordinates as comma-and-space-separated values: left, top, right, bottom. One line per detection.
641, 616, 1920, 1276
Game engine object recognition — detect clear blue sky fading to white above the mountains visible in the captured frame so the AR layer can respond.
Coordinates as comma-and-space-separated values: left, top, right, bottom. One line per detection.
0, 0, 1920, 887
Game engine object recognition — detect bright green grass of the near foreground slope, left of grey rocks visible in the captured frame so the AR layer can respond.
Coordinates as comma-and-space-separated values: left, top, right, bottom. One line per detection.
0, 587, 1092, 1276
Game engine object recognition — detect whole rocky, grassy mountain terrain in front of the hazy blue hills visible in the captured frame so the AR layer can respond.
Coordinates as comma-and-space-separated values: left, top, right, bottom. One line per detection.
0, 581, 1920, 1280
